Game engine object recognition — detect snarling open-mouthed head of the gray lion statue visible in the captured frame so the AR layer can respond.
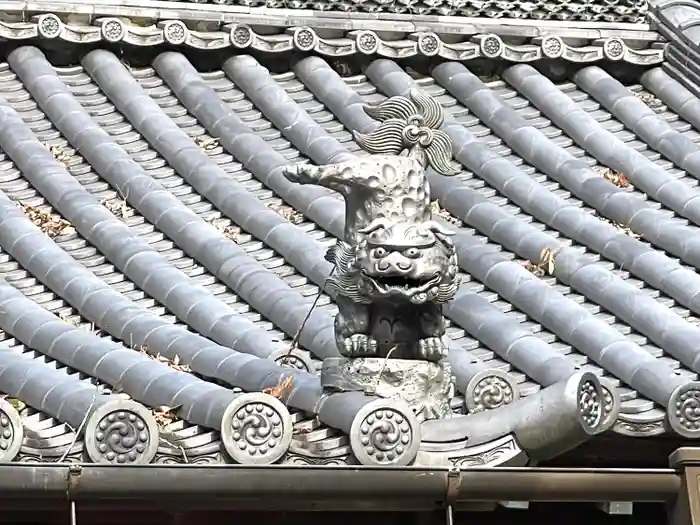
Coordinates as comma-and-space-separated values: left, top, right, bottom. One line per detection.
329, 218, 459, 304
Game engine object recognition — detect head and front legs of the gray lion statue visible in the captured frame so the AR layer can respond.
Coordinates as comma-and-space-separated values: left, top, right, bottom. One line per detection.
328, 219, 459, 361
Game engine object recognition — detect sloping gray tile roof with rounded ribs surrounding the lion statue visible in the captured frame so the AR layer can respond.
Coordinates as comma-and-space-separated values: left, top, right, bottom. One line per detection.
0, 35, 700, 464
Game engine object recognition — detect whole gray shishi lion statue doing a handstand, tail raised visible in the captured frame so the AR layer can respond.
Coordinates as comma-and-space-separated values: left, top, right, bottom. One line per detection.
285, 90, 459, 361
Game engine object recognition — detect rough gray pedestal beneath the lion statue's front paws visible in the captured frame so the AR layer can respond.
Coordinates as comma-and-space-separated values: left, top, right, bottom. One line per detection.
321, 357, 454, 421
